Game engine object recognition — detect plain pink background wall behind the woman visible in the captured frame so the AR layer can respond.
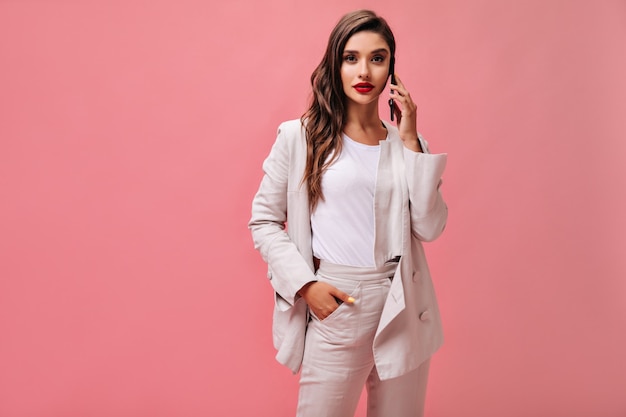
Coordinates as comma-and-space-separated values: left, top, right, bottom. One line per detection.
0, 0, 626, 417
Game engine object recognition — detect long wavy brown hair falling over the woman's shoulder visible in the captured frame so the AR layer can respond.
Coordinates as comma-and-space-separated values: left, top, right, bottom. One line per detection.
301, 10, 396, 211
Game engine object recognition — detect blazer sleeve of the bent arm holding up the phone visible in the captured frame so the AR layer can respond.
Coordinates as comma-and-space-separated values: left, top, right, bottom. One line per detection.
404, 135, 448, 242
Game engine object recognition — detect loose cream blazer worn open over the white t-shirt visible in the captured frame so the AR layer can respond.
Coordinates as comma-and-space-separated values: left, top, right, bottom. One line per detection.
248, 120, 448, 380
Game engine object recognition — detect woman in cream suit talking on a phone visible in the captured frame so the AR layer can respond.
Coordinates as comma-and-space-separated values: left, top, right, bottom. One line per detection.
249, 10, 447, 417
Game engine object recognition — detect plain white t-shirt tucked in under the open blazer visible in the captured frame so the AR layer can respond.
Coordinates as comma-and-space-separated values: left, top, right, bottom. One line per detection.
311, 135, 380, 267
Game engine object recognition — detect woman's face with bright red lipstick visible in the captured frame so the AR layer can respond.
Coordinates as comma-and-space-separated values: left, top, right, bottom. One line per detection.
341, 32, 391, 104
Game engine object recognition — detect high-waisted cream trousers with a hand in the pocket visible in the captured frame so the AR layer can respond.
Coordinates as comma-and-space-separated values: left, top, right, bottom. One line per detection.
297, 261, 430, 417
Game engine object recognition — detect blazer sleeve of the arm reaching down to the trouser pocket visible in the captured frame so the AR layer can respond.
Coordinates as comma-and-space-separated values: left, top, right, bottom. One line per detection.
248, 124, 316, 309
